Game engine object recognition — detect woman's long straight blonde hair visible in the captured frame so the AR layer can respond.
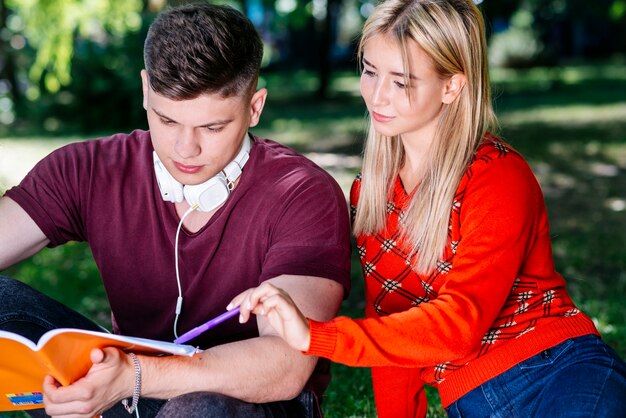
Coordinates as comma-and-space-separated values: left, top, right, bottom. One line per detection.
354, 0, 497, 273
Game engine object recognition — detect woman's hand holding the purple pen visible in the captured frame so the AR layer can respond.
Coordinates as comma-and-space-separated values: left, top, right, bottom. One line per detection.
226, 283, 311, 351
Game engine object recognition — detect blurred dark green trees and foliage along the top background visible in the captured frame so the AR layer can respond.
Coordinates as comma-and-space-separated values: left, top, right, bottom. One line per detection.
0, 0, 626, 135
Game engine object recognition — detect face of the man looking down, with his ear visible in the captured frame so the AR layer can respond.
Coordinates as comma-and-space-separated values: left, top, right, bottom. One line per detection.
141, 71, 267, 185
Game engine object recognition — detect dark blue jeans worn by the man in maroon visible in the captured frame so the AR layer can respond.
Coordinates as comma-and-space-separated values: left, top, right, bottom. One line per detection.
0, 276, 322, 418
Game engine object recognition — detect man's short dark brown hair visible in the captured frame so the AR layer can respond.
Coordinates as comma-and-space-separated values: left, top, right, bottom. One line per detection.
144, 4, 263, 100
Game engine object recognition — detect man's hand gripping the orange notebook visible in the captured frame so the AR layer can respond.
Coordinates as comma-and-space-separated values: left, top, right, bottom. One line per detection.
43, 347, 135, 418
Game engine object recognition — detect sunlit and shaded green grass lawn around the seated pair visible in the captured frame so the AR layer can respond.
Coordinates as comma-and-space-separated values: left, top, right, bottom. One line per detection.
1, 60, 626, 418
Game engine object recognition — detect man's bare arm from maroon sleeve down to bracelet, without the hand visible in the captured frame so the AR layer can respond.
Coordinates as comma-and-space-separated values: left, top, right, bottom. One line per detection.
141, 276, 344, 402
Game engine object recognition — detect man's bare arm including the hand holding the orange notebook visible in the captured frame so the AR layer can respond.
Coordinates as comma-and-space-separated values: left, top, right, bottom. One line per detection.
44, 275, 344, 417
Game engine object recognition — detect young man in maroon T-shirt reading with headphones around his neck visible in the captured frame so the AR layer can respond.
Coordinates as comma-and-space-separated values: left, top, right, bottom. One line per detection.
0, 4, 350, 418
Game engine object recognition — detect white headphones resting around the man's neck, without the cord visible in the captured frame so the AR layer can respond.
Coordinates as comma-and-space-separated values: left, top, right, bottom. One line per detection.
152, 134, 251, 212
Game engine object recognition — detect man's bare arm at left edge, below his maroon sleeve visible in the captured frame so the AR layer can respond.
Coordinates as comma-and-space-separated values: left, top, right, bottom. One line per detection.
0, 197, 49, 270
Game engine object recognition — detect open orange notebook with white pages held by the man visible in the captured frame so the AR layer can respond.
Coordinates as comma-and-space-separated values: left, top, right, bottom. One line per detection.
0, 328, 198, 411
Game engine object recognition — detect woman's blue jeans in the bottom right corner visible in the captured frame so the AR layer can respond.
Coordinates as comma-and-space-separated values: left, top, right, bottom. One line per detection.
446, 335, 626, 418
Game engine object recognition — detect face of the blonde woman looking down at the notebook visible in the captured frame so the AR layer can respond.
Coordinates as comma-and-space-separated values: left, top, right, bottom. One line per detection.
361, 35, 446, 142
